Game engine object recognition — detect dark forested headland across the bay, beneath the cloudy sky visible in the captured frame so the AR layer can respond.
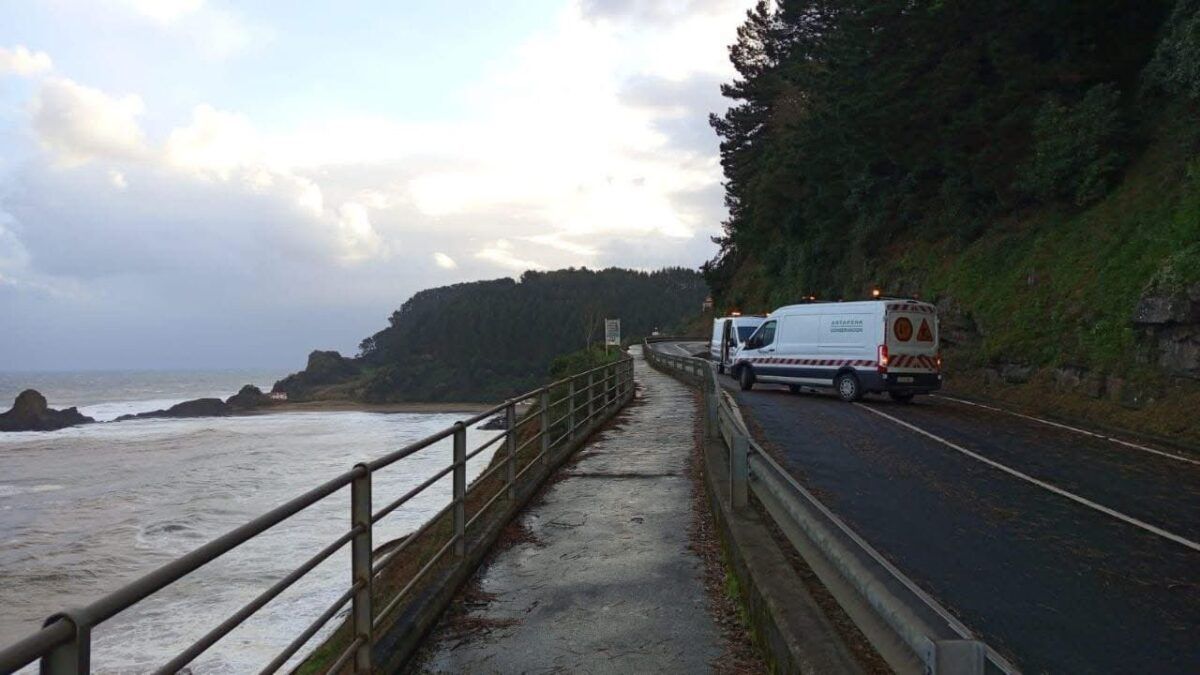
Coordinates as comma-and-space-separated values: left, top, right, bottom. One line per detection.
275, 268, 708, 402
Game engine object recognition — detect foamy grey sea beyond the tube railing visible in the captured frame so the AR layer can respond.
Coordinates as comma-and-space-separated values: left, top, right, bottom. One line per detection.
0, 370, 499, 675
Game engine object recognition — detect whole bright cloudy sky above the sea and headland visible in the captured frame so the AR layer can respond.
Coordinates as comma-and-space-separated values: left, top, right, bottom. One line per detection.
0, 0, 750, 370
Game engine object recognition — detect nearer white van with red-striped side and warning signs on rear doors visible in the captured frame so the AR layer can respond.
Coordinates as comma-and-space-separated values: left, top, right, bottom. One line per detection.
731, 299, 942, 401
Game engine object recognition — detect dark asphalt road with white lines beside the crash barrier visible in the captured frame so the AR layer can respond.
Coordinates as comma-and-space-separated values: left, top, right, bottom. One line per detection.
662, 346, 1200, 673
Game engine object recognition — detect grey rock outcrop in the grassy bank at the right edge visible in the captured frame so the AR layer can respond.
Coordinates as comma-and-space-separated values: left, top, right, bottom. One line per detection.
1133, 277, 1200, 380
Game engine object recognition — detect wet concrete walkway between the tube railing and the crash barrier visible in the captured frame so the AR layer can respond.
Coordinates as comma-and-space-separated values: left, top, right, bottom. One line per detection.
421, 351, 724, 673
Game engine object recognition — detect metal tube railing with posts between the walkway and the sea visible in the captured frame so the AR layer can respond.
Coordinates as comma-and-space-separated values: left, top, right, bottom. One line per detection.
0, 357, 634, 675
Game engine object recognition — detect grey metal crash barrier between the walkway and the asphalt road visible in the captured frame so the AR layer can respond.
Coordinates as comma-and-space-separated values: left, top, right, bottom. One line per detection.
643, 339, 1018, 675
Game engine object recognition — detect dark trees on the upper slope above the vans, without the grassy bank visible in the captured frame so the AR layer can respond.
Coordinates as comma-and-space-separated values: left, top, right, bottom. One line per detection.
704, 0, 1180, 303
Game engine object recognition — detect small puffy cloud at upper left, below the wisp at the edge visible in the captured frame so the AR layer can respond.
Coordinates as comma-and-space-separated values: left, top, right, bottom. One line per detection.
31, 78, 146, 166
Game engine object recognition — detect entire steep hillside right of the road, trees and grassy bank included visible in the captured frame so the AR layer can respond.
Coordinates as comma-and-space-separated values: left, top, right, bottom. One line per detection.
704, 0, 1200, 442
